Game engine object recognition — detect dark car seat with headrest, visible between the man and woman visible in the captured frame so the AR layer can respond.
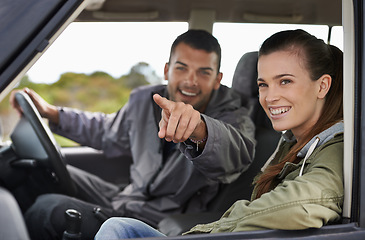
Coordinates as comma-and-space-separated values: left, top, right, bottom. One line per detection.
203, 51, 281, 211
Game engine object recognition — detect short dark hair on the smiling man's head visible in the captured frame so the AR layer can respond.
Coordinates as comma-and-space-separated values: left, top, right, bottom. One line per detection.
169, 29, 221, 73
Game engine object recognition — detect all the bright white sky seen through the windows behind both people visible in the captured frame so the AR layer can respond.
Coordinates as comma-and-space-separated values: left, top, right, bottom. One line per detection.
27, 22, 342, 86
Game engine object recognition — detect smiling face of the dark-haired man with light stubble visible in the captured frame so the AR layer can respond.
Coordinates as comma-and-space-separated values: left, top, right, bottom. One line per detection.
164, 43, 222, 112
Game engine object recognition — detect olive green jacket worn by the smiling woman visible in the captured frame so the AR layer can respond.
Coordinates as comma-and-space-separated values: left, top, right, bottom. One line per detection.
185, 122, 343, 234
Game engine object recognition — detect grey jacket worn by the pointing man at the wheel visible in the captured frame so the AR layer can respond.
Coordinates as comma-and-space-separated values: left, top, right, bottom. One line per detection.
51, 85, 255, 224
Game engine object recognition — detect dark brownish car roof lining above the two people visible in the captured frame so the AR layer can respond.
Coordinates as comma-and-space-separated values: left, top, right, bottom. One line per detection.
76, 0, 342, 26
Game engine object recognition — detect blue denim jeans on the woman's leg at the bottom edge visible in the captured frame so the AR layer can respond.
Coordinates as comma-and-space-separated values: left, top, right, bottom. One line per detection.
95, 217, 165, 240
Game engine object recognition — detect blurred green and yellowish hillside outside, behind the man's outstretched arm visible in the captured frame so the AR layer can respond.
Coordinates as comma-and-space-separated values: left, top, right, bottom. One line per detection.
0, 67, 154, 146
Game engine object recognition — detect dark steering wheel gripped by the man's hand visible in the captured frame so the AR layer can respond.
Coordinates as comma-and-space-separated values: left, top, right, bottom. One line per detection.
13, 91, 76, 196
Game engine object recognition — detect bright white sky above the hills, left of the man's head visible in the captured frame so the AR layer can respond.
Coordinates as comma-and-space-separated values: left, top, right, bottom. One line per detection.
28, 22, 188, 83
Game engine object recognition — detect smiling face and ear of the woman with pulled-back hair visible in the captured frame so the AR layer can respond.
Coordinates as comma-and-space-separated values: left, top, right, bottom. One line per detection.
257, 51, 331, 140
